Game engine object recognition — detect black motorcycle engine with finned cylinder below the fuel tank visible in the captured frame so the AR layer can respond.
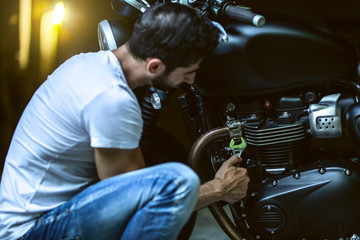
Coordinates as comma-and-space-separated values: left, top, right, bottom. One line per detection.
197, 91, 360, 239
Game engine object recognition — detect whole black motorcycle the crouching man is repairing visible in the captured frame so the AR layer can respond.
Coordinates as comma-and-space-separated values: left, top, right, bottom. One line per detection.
98, 0, 360, 240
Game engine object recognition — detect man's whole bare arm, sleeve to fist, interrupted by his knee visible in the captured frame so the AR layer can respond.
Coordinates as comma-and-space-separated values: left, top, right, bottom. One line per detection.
95, 148, 250, 210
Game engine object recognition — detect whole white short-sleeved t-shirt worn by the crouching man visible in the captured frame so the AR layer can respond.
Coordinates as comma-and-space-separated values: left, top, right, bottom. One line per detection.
0, 51, 143, 240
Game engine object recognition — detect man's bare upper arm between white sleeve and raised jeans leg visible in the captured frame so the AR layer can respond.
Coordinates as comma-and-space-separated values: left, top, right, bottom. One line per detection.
95, 148, 145, 180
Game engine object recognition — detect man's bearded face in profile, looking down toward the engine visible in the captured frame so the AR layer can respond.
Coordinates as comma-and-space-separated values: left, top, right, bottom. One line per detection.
152, 60, 201, 90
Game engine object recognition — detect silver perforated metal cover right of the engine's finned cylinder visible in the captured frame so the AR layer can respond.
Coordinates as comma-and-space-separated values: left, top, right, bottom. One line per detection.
309, 93, 342, 138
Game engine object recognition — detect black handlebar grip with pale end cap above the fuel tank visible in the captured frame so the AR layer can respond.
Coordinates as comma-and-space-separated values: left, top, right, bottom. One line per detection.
223, 4, 265, 27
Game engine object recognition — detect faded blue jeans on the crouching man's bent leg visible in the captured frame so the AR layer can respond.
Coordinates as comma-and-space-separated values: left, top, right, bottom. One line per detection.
23, 163, 199, 240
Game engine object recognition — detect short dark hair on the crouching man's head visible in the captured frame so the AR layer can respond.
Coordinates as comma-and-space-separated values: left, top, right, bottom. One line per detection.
127, 3, 219, 73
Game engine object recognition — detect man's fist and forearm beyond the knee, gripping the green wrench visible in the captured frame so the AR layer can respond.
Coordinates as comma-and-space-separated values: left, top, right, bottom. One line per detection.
195, 155, 250, 210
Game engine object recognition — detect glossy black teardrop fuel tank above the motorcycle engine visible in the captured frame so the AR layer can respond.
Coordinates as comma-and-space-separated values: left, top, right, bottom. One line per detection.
194, 16, 359, 96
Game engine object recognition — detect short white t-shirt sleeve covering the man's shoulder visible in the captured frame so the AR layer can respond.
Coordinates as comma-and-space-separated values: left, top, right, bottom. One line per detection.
82, 85, 143, 149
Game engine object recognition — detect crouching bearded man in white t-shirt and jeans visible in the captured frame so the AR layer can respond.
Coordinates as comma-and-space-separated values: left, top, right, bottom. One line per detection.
0, 3, 249, 240
